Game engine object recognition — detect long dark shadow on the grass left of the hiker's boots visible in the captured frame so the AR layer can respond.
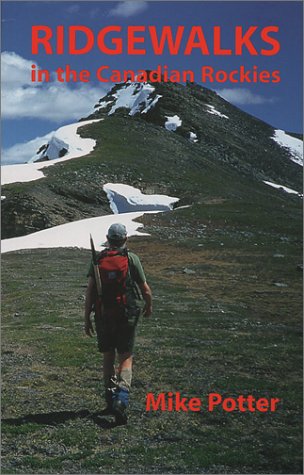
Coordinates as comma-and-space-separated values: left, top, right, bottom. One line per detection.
1, 409, 119, 429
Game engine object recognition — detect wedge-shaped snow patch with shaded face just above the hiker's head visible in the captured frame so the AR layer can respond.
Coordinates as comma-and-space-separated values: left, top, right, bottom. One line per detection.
103, 183, 179, 214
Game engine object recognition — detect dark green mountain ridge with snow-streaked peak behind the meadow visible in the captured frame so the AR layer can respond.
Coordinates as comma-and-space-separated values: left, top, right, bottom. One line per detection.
2, 83, 302, 242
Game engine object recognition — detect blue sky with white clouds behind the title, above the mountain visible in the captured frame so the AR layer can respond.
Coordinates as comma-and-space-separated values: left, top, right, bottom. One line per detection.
1, 0, 303, 158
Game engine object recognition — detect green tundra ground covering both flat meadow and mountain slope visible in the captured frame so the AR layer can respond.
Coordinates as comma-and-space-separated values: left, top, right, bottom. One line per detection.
2, 82, 302, 474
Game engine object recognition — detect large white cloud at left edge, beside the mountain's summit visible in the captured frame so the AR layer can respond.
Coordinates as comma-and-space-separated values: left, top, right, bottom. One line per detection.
1, 52, 106, 124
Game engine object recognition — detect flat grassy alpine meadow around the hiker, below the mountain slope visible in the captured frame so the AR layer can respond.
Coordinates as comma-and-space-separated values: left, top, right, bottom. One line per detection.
2, 204, 302, 474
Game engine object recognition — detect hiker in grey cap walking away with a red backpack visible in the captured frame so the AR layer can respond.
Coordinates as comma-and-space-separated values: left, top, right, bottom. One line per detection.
85, 223, 152, 424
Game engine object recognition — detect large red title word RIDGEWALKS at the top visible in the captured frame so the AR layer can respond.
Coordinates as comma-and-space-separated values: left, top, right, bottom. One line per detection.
32, 25, 281, 56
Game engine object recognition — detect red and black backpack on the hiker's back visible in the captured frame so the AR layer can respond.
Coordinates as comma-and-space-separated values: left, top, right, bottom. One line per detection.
98, 249, 129, 307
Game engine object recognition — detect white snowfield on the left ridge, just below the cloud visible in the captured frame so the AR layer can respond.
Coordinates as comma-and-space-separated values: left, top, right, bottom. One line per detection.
1, 119, 99, 185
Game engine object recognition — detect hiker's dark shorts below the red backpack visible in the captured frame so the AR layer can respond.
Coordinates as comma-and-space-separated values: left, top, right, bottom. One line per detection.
95, 308, 139, 353
